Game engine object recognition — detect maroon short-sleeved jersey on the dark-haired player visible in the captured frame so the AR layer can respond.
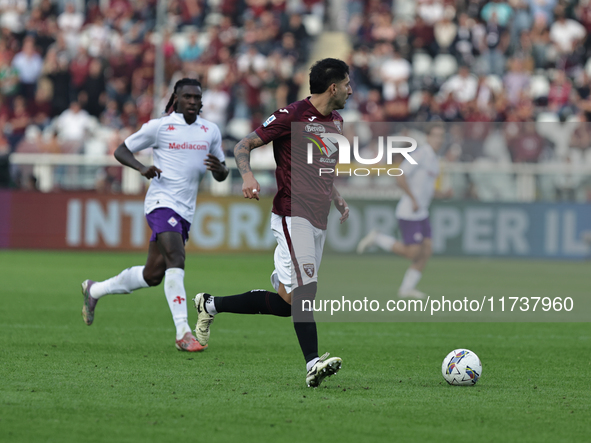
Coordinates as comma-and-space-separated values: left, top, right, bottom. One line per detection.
255, 97, 343, 229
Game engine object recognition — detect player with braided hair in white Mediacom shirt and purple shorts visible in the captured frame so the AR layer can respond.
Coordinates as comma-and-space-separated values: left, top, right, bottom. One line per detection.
82, 78, 229, 352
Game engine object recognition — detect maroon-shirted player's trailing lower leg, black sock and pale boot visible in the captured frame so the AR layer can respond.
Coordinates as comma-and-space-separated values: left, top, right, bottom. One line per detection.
193, 289, 291, 345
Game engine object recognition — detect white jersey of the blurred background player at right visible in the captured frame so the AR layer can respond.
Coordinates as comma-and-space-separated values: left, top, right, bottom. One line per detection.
396, 144, 439, 220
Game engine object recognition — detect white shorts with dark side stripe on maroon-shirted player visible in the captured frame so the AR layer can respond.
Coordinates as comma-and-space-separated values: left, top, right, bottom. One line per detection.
271, 214, 326, 294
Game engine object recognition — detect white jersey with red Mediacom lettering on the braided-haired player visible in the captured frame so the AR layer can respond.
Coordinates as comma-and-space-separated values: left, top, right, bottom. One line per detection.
125, 112, 225, 222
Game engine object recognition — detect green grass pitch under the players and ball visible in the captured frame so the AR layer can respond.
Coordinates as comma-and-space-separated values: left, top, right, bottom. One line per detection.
0, 251, 591, 443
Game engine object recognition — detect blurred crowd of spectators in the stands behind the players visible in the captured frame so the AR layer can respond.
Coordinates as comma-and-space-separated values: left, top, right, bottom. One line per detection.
0, 0, 591, 194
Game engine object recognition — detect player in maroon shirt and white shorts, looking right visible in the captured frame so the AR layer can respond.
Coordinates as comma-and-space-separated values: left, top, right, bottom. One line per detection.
194, 58, 353, 387
